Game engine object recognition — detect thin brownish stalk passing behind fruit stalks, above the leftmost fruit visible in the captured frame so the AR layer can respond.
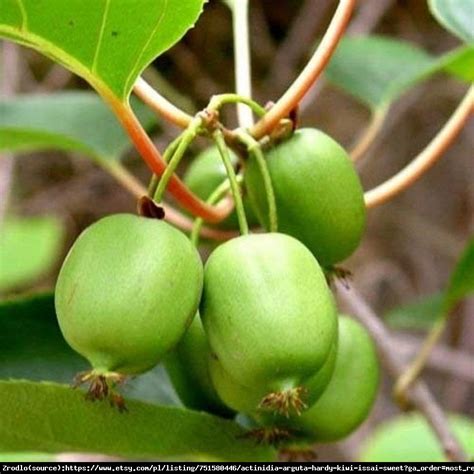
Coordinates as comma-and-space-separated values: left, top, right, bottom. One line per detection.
99, 160, 239, 240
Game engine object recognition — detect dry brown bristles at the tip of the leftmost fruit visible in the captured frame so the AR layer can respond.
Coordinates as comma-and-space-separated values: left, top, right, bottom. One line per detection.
73, 370, 127, 412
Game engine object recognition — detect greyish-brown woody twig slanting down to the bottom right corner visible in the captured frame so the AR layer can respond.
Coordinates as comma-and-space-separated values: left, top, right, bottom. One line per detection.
336, 283, 467, 462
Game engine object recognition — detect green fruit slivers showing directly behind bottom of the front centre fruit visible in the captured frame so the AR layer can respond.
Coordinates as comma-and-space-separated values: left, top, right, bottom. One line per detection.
209, 332, 337, 416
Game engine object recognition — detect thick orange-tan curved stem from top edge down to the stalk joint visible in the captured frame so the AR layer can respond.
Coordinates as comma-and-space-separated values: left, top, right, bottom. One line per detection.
250, 0, 356, 139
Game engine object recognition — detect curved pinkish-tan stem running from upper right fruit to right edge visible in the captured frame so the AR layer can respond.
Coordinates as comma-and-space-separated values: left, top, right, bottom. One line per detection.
364, 86, 474, 208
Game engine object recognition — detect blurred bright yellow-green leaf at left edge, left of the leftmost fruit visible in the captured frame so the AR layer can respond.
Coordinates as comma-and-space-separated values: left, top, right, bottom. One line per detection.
0, 217, 63, 291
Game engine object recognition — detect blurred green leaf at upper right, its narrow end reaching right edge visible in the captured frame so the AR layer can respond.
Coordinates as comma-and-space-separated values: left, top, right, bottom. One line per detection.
326, 35, 474, 109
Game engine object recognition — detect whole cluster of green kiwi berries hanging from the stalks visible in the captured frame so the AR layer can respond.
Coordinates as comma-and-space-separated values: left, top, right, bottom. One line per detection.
56, 129, 378, 444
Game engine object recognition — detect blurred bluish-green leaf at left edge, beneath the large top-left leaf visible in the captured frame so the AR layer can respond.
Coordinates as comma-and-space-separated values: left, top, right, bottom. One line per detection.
0, 92, 155, 160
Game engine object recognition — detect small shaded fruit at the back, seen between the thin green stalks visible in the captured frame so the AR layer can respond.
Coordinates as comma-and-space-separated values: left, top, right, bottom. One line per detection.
183, 146, 259, 229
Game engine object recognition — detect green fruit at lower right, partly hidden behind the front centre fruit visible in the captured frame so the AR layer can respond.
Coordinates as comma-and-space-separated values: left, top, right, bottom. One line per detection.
286, 316, 379, 443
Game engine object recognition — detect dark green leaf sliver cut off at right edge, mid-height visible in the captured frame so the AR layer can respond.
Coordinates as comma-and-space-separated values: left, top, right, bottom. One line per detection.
443, 238, 474, 312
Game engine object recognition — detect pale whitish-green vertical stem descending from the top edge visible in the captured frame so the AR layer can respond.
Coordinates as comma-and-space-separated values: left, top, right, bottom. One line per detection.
232, 0, 253, 128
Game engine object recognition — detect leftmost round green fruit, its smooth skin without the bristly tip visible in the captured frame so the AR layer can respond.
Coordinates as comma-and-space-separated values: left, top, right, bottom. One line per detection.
55, 214, 203, 374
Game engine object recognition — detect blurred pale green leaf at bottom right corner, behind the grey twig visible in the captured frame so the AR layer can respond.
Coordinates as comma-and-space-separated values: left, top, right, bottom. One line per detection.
360, 414, 474, 462
